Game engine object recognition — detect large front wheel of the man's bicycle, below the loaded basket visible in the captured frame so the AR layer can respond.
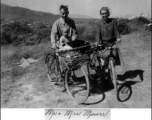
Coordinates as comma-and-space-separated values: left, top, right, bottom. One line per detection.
65, 66, 90, 104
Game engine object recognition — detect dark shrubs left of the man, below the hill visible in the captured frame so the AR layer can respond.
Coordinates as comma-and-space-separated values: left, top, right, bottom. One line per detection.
1, 20, 51, 45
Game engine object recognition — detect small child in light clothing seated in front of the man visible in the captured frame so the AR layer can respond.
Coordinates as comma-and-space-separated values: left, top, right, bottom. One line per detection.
59, 28, 72, 50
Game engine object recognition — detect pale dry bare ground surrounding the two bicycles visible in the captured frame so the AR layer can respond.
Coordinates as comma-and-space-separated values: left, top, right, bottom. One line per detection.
1, 31, 151, 108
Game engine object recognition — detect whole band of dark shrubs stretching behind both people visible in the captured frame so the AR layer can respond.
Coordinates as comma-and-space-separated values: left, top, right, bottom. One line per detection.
1, 17, 151, 45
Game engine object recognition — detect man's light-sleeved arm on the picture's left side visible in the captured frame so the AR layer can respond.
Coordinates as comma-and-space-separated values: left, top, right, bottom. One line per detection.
50, 22, 58, 48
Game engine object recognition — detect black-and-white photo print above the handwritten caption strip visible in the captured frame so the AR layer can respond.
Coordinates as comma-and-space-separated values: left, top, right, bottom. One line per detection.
0, 0, 152, 109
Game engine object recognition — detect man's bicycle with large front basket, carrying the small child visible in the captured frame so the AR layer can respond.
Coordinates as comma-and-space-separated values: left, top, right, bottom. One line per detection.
46, 45, 90, 103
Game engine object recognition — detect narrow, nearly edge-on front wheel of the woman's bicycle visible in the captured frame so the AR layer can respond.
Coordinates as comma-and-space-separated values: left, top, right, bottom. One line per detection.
109, 60, 118, 97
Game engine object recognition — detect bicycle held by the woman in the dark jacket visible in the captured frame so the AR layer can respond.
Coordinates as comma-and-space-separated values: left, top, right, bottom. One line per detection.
87, 42, 121, 98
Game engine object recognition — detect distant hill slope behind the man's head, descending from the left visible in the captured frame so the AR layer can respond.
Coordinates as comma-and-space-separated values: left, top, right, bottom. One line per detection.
1, 3, 91, 24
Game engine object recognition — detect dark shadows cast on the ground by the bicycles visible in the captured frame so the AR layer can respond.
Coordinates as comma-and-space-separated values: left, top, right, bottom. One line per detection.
85, 70, 144, 105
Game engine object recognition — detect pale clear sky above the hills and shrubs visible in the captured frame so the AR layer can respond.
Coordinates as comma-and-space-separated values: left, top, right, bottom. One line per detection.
1, 0, 151, 18
